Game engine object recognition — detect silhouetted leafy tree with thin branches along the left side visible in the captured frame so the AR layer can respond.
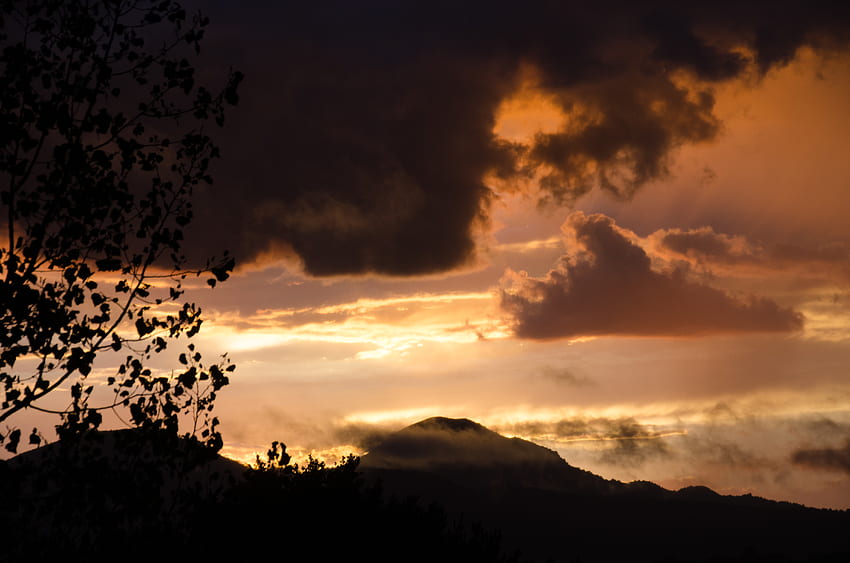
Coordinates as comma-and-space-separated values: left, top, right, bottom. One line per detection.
0, 0, 242, 452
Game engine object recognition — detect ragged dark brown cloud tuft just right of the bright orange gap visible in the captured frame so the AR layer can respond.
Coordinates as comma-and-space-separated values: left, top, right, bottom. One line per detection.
528, 73, 719, 203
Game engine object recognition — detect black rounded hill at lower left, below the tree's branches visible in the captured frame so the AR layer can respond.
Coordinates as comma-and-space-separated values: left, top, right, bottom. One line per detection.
0, 429, 245, 561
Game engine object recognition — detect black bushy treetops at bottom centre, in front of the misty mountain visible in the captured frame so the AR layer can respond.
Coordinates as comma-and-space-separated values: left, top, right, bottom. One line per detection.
206, 442, 519, 563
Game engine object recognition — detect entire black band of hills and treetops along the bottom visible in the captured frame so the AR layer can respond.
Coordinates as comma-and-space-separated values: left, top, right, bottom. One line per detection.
0, 418, 850, 563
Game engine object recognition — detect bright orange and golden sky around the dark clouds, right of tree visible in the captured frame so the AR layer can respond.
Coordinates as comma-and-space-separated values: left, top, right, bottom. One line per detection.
154, 51, 850, 507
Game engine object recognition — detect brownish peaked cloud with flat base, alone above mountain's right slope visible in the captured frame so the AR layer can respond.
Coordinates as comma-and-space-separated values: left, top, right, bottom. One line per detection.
500, 212, 803, 339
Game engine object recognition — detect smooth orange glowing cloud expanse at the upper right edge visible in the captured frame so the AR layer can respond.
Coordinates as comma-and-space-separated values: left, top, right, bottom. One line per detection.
577, 49, 850, 247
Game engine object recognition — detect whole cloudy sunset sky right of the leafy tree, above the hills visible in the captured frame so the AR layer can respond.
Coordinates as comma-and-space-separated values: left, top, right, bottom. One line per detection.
18, 1, 850, 508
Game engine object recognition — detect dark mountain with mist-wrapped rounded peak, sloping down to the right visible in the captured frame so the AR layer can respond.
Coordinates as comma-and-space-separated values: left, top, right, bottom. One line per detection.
361, 417, 850, 563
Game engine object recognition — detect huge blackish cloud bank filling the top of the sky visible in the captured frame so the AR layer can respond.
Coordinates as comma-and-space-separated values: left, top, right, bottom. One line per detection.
182, 0, 850, 276
